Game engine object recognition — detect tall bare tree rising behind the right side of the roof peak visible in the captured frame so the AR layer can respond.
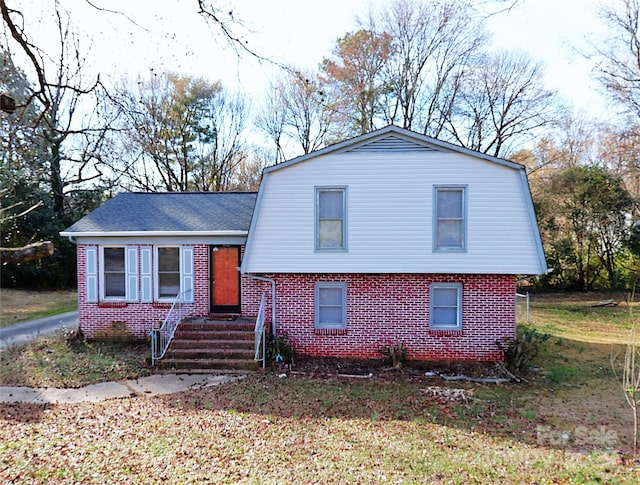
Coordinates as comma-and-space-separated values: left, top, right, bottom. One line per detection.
369, 0, 486, 137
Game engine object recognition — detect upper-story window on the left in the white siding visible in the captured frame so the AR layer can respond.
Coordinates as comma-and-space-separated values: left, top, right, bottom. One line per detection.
316, 188, 347, 251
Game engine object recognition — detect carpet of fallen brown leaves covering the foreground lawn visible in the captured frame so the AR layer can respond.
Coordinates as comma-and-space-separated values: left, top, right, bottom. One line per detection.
0, 375, 638, 483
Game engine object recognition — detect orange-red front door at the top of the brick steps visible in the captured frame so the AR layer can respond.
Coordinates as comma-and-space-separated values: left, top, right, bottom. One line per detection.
211, 246, 240, 313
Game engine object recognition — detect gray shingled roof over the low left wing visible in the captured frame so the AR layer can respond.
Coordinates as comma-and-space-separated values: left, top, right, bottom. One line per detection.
61, 192, 256, 236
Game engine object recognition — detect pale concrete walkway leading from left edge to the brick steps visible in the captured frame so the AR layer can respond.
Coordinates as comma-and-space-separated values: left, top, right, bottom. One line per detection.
0, 374, 245, 404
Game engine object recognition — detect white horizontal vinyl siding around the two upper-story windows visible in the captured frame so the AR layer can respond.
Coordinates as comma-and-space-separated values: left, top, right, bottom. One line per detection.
243, 149, 544, 274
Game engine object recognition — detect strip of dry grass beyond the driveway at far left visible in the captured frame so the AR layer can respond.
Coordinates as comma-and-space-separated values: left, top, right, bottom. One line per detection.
0, 288, 78, 327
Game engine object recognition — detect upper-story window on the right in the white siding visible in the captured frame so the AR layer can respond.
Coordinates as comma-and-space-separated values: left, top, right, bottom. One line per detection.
433, 187, 467, 251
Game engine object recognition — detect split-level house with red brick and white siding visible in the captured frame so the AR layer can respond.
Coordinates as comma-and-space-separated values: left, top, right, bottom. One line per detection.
62, 126, 547, 360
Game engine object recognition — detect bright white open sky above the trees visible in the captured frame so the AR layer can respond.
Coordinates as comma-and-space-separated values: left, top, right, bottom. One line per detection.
7, 0, 607, 116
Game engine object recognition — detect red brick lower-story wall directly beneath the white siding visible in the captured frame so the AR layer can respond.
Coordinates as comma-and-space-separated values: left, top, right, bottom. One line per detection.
250, 274, 516, 361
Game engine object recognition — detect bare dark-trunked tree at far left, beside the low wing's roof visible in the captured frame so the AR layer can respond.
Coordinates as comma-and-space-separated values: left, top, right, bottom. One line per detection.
0, 0, 111, 218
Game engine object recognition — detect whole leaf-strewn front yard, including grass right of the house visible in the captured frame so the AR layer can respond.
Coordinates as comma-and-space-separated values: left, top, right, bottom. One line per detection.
0, 296, 640, 484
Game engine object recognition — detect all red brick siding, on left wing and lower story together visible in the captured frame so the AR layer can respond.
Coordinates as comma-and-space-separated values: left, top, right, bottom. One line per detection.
78, 244, 516, 360
